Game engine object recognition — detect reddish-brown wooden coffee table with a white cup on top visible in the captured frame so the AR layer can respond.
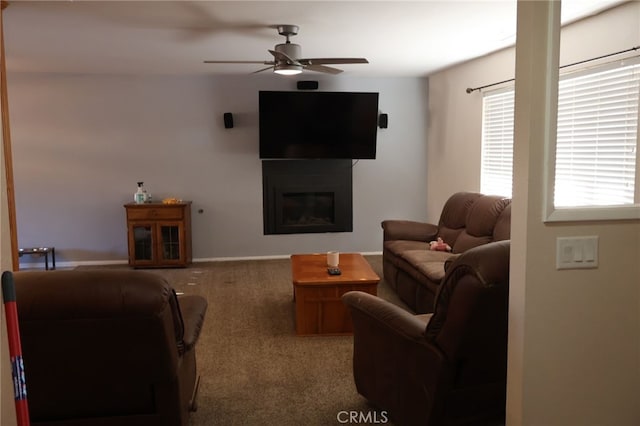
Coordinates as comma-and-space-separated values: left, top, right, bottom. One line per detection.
291, 253, 380, 336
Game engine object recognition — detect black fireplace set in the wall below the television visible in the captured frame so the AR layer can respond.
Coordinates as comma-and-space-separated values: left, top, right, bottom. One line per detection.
262, 160, 353, 235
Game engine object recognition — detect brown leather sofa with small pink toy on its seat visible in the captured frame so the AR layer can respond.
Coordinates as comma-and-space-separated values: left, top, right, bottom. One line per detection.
382, 192, 511, 313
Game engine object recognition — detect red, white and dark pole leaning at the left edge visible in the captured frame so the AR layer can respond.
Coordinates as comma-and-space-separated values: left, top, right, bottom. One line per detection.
2, 271, 29, 426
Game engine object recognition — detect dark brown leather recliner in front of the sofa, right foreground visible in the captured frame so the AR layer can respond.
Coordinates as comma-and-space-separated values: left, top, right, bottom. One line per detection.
343, 240, 510, 426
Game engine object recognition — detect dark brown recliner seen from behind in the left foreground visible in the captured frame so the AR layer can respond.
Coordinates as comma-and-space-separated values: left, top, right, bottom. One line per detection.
14, 270, 207, 426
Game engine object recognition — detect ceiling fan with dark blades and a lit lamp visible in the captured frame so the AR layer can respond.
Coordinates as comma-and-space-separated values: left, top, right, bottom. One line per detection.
204, 25, 369, 75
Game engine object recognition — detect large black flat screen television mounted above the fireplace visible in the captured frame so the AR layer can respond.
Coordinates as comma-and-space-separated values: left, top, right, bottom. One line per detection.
259, 91, 378, 159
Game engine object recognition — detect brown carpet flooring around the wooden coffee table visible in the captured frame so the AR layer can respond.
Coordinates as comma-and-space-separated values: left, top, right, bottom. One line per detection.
136, 256, 402, 426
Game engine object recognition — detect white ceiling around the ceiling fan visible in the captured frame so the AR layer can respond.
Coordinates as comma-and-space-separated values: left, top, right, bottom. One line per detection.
4, 0, 621, 76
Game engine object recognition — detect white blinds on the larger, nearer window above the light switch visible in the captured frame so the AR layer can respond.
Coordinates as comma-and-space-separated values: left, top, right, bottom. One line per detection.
554, 64, 640, 207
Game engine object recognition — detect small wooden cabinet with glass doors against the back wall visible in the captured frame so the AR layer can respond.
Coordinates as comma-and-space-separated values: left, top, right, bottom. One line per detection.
124, 202, 191, 268
